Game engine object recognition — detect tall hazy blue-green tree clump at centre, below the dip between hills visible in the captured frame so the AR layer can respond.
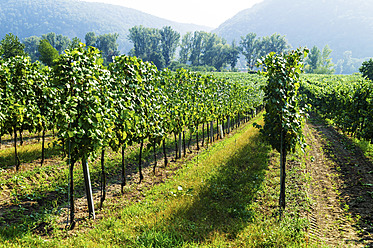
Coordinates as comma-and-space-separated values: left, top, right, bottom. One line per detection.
128, 26, 290, 71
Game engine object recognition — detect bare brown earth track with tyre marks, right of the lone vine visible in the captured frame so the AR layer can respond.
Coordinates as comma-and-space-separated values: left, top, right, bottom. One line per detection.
304, 116, 373, 247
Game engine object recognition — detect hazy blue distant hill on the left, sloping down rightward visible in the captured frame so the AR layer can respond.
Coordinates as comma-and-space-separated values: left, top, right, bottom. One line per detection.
0, 0, 211, 52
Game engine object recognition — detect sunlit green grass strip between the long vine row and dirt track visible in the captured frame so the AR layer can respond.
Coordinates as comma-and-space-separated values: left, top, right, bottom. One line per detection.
0, 114, 316, 247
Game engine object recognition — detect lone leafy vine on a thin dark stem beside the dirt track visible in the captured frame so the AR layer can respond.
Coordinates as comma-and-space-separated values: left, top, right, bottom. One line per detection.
258, 49, 308, 213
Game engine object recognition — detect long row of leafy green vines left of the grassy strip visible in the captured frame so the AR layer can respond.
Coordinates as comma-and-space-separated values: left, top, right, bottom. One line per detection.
0, 45, 264, 229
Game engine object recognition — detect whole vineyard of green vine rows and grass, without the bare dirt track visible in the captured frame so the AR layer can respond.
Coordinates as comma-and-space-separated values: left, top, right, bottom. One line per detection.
0, 45, 373, 247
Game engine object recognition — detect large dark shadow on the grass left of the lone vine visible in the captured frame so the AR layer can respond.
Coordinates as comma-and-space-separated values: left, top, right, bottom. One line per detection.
138, 134, 270, 247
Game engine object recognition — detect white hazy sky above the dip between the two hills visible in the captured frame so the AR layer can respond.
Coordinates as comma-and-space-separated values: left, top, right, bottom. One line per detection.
83, 0, 263, 28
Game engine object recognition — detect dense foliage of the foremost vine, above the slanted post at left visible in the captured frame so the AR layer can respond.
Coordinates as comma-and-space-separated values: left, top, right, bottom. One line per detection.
53, 44, 114, 161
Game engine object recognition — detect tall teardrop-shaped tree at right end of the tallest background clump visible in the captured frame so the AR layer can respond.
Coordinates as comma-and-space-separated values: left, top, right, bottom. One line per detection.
159, 26, 180, 67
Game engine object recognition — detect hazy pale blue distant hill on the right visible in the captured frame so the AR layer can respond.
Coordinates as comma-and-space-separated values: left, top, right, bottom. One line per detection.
214, 0, 373, 60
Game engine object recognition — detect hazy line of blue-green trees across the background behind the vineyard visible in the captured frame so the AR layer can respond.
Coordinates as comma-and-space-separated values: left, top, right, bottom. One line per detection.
0, 26, 354, 74
